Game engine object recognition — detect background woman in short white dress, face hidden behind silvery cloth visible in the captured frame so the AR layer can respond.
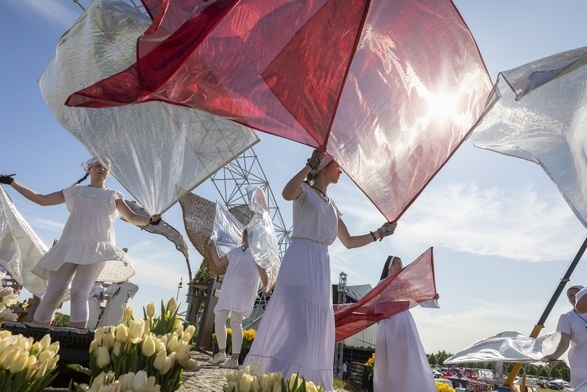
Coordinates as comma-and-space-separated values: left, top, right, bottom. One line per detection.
208, 229, 267, 369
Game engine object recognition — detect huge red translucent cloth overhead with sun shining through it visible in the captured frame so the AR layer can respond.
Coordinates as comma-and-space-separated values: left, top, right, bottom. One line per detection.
66, 0, 491, 220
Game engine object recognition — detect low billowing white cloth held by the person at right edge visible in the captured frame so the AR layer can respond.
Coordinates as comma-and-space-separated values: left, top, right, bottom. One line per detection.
444, 331, 560, 364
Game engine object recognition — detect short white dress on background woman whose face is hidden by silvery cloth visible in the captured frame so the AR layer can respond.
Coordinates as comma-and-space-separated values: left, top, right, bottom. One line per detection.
214, 247, 259, 318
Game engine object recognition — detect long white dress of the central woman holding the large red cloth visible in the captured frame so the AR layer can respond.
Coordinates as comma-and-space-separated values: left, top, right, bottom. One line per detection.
244, 184, 341, 391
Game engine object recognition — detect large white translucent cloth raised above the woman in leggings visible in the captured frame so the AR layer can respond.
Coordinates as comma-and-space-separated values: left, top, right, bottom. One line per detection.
39, 0, 258, 214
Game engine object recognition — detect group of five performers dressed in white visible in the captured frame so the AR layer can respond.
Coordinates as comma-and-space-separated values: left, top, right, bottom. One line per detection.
0, 150, 587, 392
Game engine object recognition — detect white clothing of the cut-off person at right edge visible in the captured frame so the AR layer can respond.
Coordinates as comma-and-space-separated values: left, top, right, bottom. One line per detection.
556, 310, 587, 388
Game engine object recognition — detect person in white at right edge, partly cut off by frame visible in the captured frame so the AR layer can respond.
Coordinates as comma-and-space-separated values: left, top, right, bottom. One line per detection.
544, 284, 587, 388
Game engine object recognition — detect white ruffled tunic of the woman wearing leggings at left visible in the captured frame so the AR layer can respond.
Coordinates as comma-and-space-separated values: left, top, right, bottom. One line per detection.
32, 185, 135, 282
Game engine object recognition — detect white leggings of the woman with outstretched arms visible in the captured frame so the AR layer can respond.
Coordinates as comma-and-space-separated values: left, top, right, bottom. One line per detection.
34, 261, 106, 324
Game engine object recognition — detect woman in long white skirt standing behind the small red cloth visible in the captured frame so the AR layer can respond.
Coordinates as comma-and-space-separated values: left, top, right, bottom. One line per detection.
373, 256, 436, 392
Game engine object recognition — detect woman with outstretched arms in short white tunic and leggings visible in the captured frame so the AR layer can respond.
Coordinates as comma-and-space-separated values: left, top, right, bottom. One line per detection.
0, 158, 161, 328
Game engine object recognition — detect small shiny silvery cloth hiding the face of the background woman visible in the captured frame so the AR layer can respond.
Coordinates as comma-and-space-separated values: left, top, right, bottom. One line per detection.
210, 188, 281, 289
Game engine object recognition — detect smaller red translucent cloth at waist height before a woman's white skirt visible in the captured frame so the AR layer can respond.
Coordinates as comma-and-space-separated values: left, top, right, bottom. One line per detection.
334, 248, 437, 342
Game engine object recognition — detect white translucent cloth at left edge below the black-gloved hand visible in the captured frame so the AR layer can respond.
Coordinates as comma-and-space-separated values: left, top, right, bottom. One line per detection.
0, 186, 47, 296
